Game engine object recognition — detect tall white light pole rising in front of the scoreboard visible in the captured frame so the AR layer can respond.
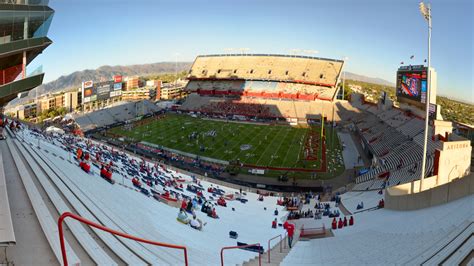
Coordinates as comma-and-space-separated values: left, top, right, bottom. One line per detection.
419, 2, 431, 191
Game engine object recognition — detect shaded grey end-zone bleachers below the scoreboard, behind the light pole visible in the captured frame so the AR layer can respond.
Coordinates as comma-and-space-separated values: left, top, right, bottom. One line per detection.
354, 103, 440, 190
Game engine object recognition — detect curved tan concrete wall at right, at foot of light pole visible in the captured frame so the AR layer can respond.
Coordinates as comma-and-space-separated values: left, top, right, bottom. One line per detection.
385, 173, 474, 210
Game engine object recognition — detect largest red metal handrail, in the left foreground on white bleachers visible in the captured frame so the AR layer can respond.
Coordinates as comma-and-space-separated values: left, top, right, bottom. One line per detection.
58, 212, 188, 266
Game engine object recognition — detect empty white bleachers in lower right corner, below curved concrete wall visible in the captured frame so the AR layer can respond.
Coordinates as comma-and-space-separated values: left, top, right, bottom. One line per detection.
281, 191, 474, 266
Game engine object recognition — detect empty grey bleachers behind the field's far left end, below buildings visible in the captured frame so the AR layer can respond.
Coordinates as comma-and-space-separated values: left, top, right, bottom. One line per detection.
74, 101, 159, 131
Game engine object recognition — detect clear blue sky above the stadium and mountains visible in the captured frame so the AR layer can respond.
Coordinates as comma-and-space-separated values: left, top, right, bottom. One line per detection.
34, 0, 474, 102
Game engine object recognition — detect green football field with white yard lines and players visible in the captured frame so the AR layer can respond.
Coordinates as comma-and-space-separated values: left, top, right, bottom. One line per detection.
109, 114, 340, 176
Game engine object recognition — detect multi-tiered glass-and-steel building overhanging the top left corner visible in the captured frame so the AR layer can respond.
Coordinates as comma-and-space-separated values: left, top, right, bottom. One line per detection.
0, 1, 54, 106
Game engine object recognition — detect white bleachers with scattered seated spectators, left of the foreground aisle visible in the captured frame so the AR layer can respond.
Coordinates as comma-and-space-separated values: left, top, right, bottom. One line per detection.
7, 128, 286, 265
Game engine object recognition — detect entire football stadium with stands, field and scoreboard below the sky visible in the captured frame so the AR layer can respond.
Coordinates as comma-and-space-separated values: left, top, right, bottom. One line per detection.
0, 0, 474, 266
